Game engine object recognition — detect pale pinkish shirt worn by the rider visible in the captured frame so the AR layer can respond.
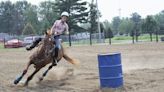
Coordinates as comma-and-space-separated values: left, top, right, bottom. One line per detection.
52, 20, 68, 34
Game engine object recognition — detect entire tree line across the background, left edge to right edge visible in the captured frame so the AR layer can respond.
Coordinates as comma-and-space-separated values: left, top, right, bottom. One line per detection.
0, 0, 164, 45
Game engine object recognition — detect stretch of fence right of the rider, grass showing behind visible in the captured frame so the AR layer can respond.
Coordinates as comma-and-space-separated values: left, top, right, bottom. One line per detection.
64, 33, 164, 45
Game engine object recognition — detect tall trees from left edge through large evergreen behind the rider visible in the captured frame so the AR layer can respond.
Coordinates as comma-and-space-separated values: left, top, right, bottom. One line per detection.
0, 0, 89, 35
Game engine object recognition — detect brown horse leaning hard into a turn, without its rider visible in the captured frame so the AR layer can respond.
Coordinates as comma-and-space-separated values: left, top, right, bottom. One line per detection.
14, 30, 79, 86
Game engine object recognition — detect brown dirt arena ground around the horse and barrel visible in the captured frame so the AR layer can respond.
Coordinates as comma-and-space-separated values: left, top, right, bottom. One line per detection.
0, 43, 164, 92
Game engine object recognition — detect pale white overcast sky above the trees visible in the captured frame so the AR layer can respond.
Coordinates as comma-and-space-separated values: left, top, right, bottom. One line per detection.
0, 0, 164, 21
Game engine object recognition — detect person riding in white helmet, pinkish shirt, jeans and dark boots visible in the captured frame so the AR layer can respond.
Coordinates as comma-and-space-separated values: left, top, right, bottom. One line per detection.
26, 12, 69, 57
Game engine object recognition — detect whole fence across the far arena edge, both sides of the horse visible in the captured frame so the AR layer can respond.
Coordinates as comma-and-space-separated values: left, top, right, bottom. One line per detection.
0, 32, 164, 46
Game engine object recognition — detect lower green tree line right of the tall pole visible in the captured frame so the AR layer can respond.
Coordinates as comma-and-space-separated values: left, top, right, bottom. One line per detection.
103, 11, 164, 43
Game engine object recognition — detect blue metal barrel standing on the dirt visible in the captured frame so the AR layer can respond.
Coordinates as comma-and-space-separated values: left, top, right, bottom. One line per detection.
98, 53, 123, 88
